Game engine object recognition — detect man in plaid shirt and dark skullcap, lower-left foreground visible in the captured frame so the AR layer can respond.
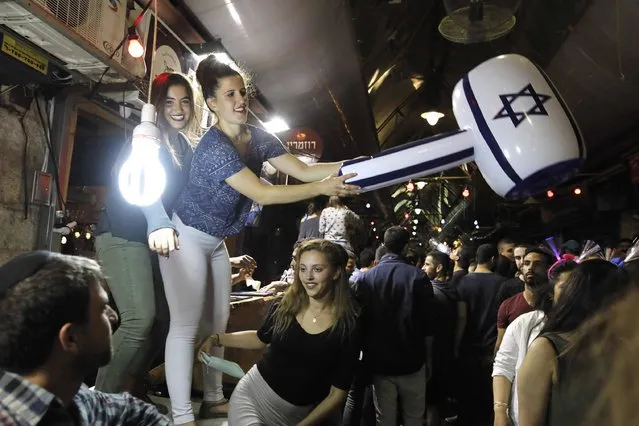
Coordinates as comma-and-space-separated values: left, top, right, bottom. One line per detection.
0, 251, 171, 426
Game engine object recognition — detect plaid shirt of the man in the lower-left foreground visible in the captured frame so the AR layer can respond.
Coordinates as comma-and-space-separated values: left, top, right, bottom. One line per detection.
0, 369, 172, 426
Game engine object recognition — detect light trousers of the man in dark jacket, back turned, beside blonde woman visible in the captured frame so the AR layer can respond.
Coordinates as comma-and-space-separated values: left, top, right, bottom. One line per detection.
373, 366, 426, 426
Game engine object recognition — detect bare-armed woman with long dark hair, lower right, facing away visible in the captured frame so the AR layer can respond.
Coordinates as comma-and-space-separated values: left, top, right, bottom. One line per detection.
517, 259, 628, 426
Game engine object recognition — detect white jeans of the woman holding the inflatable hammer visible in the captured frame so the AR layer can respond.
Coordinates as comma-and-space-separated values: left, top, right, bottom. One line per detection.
160, 214, 231, 424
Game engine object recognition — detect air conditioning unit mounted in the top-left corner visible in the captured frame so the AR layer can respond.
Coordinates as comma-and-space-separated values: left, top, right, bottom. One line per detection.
0, 0, 134, 82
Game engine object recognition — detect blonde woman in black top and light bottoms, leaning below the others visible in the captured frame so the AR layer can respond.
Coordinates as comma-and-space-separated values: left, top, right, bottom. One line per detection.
202, 240, 359, 426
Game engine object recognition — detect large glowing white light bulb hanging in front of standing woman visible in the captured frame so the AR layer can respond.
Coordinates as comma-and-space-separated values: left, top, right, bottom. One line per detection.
118, 104, 166, 206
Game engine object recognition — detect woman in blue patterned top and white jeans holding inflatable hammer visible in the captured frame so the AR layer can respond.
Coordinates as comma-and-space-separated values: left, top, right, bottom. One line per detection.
149, 55, 359, 425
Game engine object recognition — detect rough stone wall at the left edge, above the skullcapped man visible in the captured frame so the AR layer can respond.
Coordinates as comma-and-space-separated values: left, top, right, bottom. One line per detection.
0, 94, 46, 264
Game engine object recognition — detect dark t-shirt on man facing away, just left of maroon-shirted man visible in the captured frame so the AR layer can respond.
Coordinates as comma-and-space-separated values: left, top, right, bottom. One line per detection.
457, 272, 504, 354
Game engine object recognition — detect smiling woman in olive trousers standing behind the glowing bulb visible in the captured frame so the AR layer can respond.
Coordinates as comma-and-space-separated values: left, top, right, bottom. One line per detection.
96, 73, 194, 397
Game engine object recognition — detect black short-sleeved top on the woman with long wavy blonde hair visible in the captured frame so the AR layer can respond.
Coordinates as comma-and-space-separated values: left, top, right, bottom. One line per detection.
257, 303, 360, 406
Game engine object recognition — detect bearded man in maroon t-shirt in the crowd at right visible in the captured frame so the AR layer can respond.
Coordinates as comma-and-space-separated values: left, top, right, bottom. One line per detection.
495, 248, 551, 353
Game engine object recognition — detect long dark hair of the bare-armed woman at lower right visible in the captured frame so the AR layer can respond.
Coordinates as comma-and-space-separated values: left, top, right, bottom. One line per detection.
542, 259, 629, 333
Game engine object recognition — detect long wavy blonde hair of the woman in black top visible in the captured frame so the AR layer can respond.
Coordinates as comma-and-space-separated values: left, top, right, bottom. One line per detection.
273, 239, 358, 339
